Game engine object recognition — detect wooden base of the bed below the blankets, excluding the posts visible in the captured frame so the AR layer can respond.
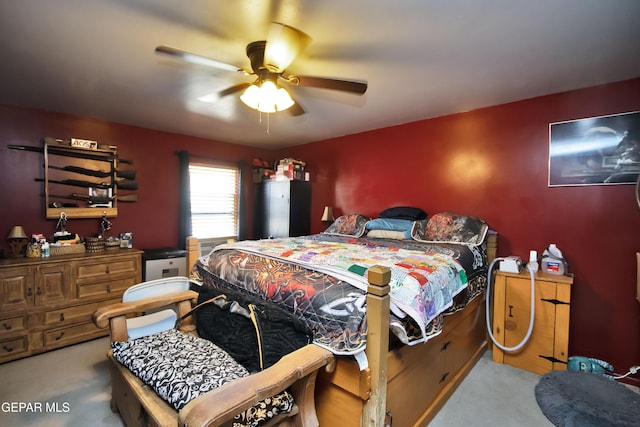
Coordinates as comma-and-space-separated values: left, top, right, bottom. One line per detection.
316, 296, 487, 427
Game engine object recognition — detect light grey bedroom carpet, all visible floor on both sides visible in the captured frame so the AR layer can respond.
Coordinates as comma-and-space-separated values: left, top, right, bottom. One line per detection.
0, 338, 616, 427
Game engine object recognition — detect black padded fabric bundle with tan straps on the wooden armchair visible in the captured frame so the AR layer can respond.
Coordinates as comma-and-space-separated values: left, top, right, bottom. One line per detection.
181, 287, 313, 372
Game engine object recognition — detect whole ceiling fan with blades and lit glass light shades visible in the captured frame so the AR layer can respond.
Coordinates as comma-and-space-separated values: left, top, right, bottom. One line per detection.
155, 22, 367, 116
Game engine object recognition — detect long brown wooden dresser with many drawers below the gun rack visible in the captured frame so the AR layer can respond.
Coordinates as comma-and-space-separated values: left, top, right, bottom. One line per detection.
0, 249, 142, 363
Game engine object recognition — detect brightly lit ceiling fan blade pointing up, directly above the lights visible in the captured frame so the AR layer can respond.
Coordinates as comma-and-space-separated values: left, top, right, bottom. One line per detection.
264, 22, 311, 73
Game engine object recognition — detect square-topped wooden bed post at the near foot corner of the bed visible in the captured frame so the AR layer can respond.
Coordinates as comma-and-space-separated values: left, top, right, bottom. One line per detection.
361, 265, 391, 427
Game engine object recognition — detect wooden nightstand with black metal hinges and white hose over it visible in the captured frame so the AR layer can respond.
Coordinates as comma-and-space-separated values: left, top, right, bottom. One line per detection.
491, 270, 573, 374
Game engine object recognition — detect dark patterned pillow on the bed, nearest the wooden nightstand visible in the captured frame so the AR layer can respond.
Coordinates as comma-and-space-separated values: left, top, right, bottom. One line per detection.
412, 212, 489, 246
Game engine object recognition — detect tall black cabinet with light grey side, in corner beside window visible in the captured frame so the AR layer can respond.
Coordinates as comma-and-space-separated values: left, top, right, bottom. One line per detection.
255, 180, 311, 239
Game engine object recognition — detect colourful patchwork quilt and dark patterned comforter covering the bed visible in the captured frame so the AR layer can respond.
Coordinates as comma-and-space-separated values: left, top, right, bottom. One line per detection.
195, 236, 482, 354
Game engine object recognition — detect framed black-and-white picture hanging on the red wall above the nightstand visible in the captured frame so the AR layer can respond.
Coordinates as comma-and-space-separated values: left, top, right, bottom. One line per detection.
549, 111, 640, 187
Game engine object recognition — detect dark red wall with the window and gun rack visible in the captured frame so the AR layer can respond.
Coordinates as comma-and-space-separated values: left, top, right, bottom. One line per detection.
0, 106, 271, 252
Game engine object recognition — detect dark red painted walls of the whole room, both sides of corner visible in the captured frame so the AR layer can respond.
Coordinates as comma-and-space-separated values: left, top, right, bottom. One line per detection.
0, 79, 640, 384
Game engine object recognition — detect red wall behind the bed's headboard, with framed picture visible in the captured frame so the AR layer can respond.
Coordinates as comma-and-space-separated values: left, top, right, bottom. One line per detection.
276, 79, 640, 384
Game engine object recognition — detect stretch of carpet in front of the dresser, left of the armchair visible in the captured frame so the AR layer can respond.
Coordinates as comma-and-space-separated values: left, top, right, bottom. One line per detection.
0, 338, 124, 427
